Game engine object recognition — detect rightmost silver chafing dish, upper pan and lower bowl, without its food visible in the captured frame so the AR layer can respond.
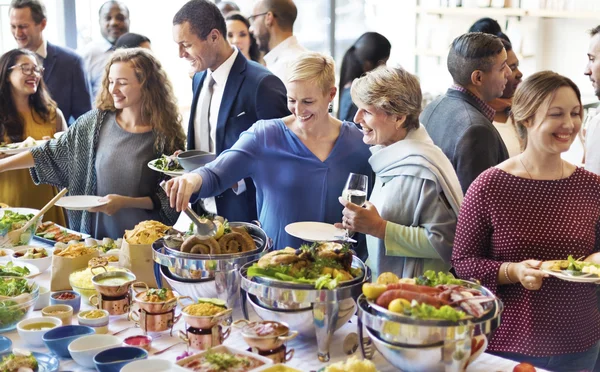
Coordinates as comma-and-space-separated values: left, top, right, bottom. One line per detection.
357, 281, 504, 372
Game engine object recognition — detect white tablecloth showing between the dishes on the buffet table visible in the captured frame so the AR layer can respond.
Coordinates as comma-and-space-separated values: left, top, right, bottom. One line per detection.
4, 262, 541, 372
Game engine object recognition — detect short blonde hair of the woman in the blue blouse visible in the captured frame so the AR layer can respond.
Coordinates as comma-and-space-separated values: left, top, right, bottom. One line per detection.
287, 52, 335, 94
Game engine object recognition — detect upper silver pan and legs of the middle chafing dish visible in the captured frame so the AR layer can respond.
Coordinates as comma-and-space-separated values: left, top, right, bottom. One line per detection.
240, 257, 371, 362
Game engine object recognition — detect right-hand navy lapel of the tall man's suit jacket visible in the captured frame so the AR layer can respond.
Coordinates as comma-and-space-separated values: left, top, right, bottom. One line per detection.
216, 52, 247, 154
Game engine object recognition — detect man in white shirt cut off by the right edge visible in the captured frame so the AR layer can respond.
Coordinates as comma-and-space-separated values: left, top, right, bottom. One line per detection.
584, 25, 600, 175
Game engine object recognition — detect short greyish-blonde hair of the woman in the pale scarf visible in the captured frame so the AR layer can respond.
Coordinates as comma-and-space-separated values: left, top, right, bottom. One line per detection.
350, 66, 423, 131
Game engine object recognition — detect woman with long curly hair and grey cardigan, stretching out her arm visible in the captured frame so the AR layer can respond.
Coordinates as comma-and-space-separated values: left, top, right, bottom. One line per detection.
0, 48, 185, 238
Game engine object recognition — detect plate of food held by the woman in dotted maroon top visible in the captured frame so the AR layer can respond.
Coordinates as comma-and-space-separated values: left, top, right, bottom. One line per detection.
540, 256, 600, 283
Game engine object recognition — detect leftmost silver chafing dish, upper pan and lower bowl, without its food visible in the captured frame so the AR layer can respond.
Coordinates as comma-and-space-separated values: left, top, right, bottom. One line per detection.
152, 222, 272, 308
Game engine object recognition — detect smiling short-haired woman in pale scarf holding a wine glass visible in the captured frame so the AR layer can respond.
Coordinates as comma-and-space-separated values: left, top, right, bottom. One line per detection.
338, 66, 463, 278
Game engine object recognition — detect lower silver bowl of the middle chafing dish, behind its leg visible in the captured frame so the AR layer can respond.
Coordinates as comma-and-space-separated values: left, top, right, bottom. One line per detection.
247, 294, 356, 338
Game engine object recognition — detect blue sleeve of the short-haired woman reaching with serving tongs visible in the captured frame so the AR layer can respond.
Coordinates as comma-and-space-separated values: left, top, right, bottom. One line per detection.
191, 122, 261, 202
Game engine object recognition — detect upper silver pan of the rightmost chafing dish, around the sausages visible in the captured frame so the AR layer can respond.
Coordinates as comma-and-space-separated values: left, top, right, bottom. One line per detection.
357, 281, 504, 346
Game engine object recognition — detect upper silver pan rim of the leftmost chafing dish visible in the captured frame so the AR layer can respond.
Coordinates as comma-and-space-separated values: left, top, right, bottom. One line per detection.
152, 222, 272, 280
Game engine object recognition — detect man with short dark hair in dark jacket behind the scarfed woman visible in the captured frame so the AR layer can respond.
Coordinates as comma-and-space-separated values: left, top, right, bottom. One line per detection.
420, 32, 511, 193
